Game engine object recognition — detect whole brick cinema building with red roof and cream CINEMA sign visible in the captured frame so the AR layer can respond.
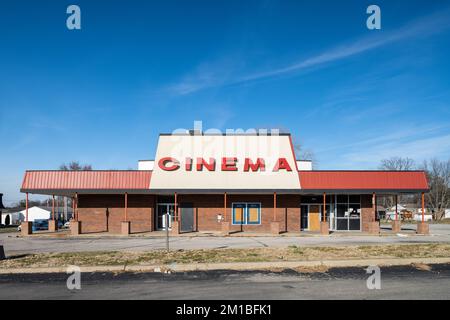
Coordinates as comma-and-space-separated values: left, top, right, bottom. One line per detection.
21, 131, 428, 234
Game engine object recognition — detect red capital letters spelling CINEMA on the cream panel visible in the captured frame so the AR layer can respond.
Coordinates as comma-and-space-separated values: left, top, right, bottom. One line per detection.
158, 157, 292, 172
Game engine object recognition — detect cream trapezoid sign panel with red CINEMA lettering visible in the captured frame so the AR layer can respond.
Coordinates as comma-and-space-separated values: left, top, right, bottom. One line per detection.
150, 135, 300, 192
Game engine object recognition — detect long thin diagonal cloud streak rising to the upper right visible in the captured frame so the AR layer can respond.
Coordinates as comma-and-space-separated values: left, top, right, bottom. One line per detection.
163, 8, 450, 95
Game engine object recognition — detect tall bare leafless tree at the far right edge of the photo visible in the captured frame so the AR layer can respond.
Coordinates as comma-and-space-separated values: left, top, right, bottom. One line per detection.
423, 159, 450, 220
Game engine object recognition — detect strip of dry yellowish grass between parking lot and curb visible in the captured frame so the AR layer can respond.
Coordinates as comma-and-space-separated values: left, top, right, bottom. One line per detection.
0, 244, 450, 268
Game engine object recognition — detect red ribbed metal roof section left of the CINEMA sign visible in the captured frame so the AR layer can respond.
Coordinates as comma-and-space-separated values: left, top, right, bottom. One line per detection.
22, 170, 151, 192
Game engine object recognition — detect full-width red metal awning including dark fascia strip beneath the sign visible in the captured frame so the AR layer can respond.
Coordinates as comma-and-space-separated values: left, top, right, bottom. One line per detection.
21, 170, 429, 196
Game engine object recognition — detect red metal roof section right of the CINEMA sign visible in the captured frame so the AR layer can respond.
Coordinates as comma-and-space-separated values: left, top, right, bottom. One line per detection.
299, 171, 428, 191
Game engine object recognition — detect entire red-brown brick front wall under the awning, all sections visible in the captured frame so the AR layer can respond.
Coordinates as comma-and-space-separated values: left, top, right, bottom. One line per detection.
78, 194, 375, 233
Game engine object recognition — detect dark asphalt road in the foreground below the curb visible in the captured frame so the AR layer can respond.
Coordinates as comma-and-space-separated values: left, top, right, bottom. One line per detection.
0, 265, 450, 300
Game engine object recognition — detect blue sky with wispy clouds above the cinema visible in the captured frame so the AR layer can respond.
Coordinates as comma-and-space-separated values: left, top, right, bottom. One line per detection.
0, 0, 450, 204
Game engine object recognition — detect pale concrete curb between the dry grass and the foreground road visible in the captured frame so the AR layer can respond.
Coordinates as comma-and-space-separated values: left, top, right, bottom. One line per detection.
0, 258, 450, 274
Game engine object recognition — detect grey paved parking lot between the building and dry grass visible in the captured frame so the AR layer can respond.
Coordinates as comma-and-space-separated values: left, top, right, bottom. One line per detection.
0, 224, 450, 256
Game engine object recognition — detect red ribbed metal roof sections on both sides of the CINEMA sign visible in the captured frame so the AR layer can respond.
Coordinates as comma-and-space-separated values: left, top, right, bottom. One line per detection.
21, 170, 429, 193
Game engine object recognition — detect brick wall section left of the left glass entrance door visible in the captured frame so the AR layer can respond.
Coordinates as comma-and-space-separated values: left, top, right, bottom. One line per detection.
78, 194, 155, 233
